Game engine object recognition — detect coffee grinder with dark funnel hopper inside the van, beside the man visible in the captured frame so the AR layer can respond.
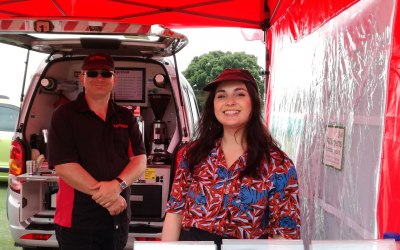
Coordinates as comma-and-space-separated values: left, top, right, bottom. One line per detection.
148, 94, 171, 164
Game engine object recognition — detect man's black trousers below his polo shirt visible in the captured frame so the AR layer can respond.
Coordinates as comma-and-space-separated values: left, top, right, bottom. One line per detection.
55, 224, 128, 250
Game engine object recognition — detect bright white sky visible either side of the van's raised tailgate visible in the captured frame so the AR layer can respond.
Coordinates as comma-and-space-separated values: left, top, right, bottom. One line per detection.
0, 28, 265, 102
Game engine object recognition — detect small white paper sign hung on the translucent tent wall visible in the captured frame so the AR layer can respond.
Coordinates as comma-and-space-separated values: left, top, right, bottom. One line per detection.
323, 125, 344, 170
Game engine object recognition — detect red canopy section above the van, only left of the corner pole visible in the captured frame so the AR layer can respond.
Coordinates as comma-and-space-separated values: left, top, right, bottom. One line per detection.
0, 0, 266, 28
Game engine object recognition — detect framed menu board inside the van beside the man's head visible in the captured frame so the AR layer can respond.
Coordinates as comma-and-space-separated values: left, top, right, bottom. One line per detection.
113, 68, 146, 103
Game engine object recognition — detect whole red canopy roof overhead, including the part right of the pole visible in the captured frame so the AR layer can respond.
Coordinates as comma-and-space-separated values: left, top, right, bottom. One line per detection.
0, 0, 357, 30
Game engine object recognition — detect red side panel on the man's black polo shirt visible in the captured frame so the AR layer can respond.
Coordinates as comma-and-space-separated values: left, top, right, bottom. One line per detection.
54, 178, 74, 228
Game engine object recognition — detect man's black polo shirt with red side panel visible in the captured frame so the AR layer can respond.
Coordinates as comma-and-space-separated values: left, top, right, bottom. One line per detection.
47, 93, 145, 229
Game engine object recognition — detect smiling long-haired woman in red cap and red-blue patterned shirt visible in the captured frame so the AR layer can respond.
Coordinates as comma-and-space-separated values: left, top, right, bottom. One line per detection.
162, 69, 300, 248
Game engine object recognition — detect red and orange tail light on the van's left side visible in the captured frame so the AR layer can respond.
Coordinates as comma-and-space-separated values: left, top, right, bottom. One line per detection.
9, 139, 26, 193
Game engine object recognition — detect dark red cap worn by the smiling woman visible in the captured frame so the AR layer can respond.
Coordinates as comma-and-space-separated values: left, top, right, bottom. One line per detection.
203, 69, 258, 92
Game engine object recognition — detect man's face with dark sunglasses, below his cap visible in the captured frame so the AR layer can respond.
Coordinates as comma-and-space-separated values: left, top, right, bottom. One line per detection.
81, 70, 116, 98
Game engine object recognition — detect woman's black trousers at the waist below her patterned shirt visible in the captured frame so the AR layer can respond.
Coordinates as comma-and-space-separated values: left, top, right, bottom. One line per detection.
179, 227, 234, 250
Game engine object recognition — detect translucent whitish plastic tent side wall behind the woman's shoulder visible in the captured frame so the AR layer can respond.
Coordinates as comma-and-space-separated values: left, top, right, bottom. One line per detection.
269, 0, 396, 242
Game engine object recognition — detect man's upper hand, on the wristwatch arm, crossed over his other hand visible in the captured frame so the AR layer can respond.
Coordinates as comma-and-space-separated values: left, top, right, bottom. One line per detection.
92, 180, 121, 209
